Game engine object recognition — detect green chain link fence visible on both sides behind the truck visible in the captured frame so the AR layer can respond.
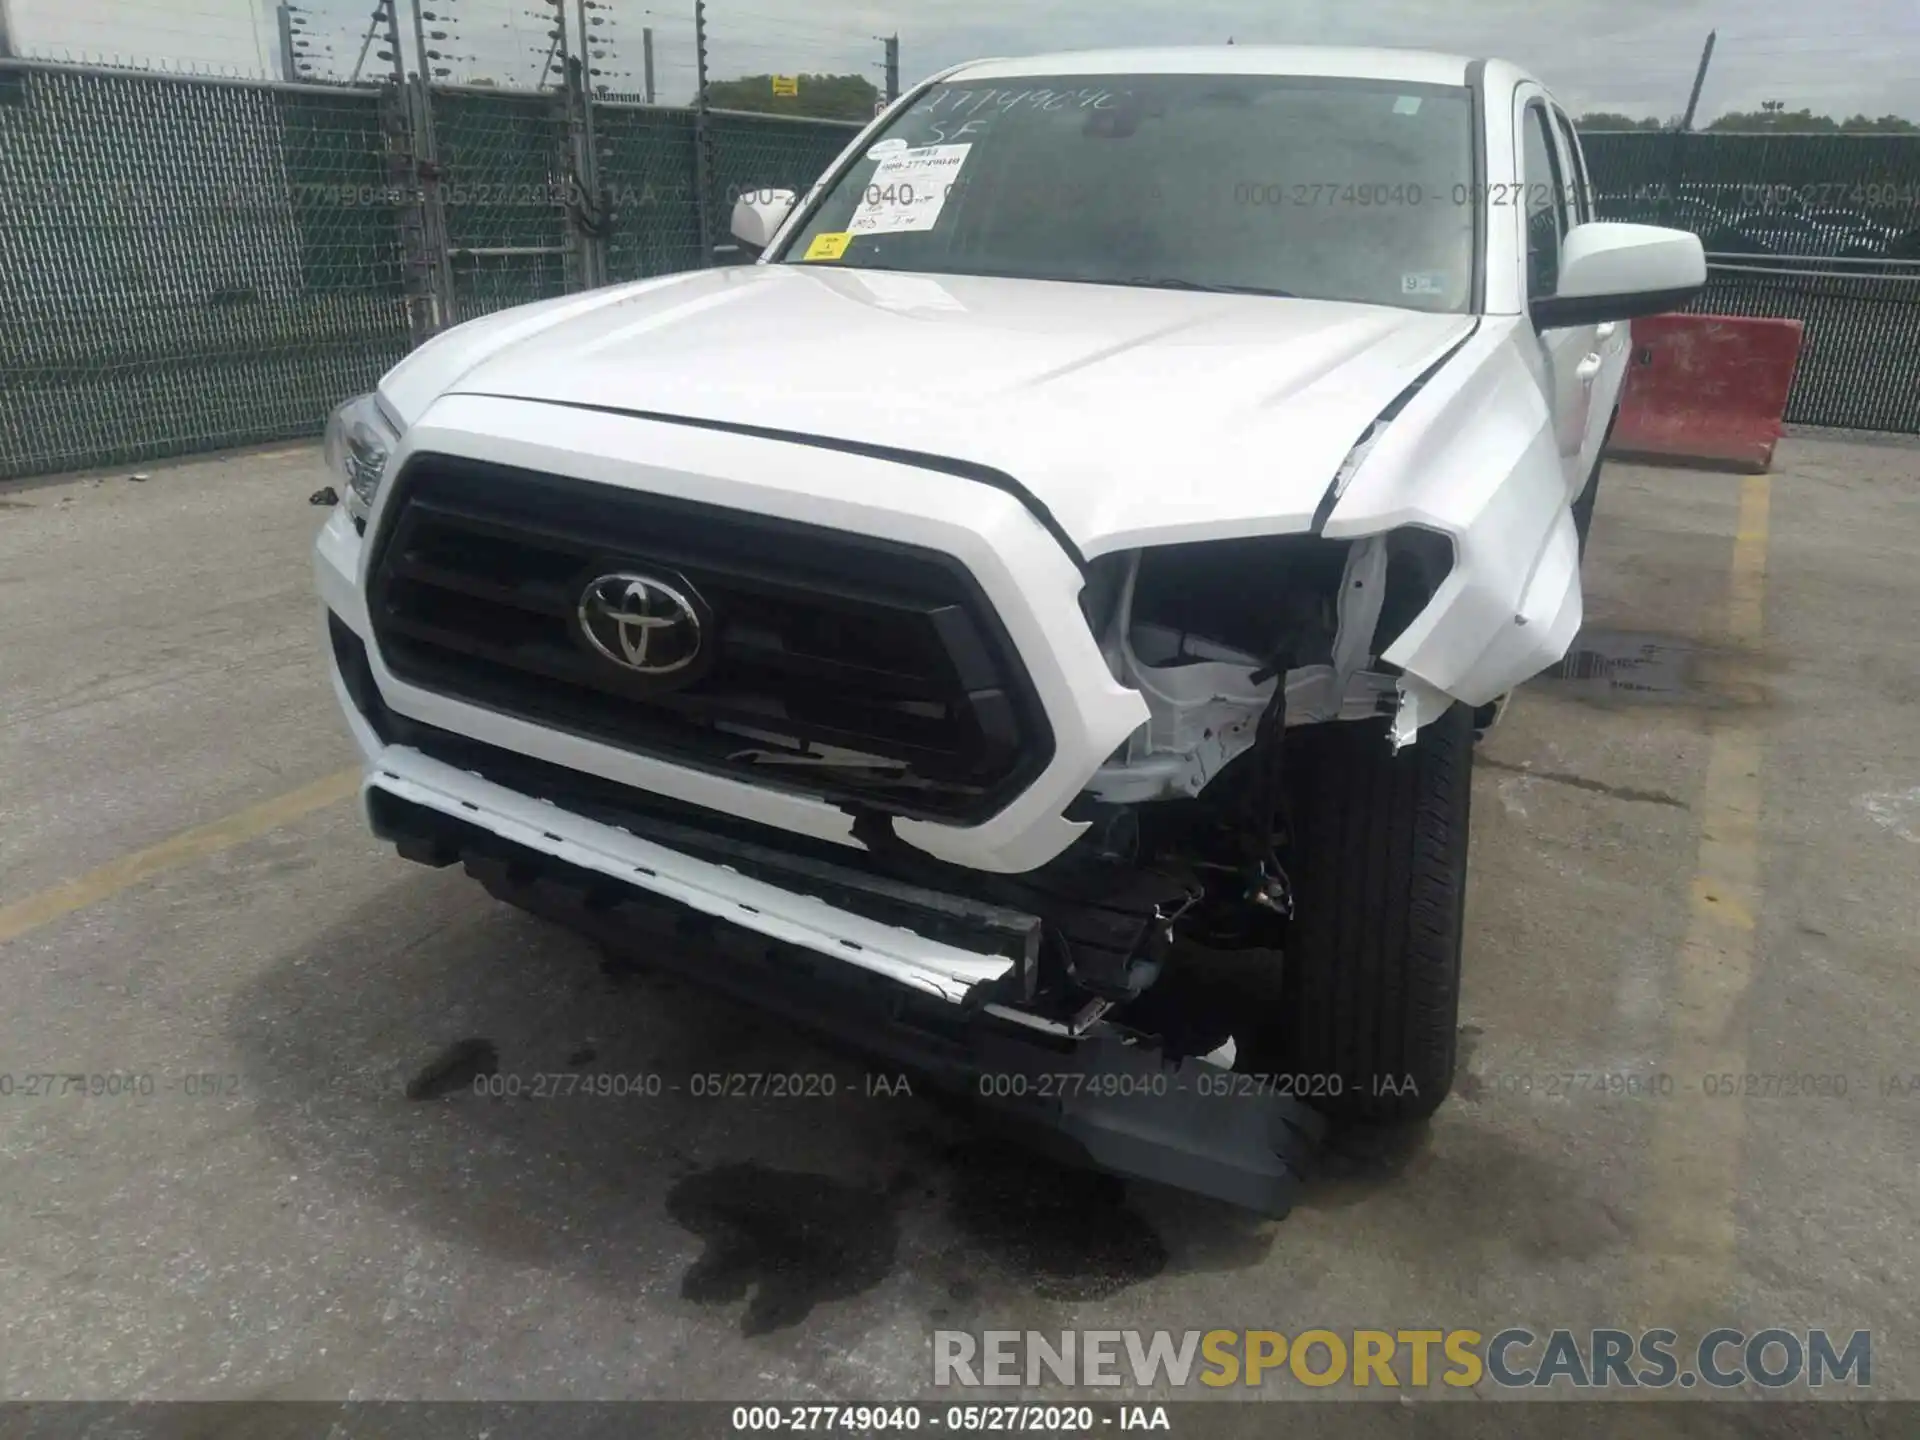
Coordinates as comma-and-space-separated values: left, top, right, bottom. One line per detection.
11, 60, 1920, 478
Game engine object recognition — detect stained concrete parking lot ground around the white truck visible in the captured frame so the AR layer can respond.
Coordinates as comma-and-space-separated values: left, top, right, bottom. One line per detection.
0, 438, 1920, 1400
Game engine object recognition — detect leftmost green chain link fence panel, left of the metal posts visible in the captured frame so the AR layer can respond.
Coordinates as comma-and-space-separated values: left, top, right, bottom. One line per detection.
0, 67, 409, 476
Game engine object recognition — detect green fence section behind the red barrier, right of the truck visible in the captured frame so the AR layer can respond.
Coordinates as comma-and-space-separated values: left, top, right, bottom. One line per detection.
1580, 131, 1920, 434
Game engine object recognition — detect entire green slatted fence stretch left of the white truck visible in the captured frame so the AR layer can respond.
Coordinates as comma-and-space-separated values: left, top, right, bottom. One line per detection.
0, 61, 856, 478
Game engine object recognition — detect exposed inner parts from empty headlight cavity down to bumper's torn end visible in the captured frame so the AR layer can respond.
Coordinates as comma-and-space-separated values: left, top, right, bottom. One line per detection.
641, 528, 1452, 1052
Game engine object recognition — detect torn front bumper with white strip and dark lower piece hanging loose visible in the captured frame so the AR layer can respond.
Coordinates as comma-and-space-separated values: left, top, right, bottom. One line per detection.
367, 768, 1323, 1215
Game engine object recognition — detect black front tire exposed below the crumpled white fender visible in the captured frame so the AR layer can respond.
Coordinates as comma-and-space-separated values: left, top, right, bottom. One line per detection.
1242, 705, 1473, 1121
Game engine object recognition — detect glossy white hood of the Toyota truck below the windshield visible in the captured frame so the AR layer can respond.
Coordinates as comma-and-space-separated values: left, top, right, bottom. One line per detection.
382, 265, 1473, 557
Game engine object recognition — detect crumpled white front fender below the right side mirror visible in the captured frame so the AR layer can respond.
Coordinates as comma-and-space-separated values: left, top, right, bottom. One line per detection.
1323, 317, 1582, 718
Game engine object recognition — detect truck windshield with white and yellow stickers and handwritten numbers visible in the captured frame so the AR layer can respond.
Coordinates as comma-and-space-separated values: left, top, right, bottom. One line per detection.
783, 75, 1475, 311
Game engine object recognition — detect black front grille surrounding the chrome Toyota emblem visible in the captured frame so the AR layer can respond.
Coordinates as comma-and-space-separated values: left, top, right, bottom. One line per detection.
369, 455, 1052, 820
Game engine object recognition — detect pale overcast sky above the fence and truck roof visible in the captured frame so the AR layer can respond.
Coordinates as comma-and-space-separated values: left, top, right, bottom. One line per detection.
0, 0, 1920, 121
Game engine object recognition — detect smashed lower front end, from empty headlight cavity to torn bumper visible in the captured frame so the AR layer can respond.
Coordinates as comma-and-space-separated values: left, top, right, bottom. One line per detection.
332, 530, 1452, 1213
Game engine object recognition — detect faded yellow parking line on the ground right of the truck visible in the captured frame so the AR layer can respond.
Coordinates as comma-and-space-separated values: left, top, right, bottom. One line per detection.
1636, 474, 1772, 1329
